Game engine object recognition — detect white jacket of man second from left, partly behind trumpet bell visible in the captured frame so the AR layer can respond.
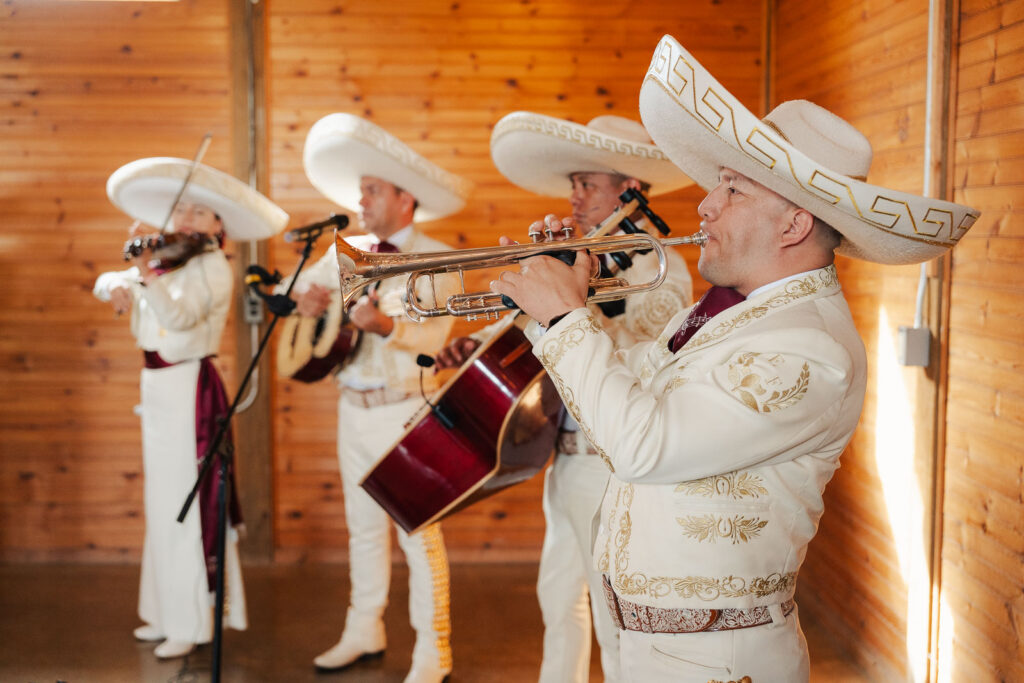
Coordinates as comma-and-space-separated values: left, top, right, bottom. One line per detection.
296, 227, 458, 394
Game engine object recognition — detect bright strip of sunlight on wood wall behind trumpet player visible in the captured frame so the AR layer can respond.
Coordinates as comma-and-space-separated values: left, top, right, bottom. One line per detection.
874, 306, 931, 681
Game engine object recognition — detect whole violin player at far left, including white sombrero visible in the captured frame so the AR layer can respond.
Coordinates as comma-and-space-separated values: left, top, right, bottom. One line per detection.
93, 158, 288, 658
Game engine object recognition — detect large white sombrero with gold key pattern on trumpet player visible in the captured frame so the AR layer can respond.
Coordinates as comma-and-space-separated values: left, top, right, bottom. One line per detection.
640, 36, 981, 264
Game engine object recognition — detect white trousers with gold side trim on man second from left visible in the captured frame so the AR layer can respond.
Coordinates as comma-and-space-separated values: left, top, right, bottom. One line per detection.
338, 396, 452, 671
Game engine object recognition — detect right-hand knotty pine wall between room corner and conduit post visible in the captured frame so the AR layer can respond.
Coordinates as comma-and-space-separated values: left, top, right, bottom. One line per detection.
773, 0, 931, 681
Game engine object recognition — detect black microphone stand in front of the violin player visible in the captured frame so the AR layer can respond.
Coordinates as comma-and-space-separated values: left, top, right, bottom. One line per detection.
177, 230, 321, 683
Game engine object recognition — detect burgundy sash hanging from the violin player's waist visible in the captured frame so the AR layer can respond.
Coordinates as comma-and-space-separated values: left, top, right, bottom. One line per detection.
144, 351, 242, 591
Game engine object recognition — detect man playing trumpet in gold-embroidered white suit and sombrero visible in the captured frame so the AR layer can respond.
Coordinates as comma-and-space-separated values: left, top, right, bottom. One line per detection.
492, 36, 977, 683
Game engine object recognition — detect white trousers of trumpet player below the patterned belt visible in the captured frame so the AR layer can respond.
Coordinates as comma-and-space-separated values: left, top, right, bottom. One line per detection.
618, 609, 810, 683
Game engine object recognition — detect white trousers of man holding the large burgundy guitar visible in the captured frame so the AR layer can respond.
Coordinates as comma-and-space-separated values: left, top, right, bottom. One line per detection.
537, 454, 621, 683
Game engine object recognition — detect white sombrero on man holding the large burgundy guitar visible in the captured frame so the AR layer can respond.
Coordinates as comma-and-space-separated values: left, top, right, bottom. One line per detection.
490, 112, 692, 197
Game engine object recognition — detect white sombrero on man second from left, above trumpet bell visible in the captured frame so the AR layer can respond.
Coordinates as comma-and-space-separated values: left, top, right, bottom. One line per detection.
302, 114, 473, 221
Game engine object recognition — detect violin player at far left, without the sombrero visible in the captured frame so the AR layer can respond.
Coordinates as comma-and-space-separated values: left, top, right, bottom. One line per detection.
93, 201, 247, 658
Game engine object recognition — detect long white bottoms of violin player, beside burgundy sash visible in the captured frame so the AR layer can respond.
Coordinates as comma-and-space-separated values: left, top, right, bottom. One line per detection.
138, 360, 248, 643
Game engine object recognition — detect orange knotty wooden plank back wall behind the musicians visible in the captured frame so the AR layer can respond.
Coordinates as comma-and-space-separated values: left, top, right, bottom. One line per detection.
0, 0, 762, 561
